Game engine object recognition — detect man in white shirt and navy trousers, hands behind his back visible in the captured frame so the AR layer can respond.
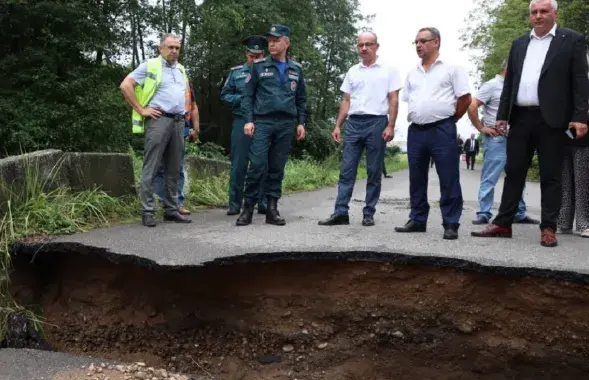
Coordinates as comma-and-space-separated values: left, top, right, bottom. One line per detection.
395, 28, 471, 240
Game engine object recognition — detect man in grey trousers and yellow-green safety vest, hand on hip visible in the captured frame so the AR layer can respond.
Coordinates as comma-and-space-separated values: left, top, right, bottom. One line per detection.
121, 34, 196, 227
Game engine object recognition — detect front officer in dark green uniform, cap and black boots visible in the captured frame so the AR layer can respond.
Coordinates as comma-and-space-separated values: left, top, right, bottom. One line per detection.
236, 25, 307, 226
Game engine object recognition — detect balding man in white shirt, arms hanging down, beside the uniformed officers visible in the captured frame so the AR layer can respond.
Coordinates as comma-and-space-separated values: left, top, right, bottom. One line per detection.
319, 32, 401, 226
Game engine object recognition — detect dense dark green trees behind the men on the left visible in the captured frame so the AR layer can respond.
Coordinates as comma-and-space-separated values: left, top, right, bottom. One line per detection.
0, 0, 367, 159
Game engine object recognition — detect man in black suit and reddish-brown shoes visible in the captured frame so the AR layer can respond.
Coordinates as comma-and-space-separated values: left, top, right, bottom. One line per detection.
471, 0, 589, 247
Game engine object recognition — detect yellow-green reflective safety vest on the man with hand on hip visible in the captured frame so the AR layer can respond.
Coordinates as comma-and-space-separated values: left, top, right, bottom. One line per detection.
131, 56, 190, 134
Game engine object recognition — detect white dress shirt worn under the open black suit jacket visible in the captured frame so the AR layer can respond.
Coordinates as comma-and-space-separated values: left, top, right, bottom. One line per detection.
515, 24, 556, 107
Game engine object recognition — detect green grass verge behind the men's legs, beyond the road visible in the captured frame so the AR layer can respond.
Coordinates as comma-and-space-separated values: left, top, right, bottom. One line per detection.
186, 155, 407, 207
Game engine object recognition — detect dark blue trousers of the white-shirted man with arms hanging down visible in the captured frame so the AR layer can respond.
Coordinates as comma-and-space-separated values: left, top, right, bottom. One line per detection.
334, 115, 388, 216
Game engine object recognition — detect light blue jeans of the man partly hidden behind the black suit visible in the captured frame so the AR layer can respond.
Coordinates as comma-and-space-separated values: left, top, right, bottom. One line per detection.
477, 135, 526, 222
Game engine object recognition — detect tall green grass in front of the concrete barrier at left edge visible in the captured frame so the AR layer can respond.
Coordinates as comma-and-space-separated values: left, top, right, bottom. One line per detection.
0, 154, 138, 342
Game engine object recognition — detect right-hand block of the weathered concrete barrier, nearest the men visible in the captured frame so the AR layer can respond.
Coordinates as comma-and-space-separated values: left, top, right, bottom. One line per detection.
65, 153, 137, 197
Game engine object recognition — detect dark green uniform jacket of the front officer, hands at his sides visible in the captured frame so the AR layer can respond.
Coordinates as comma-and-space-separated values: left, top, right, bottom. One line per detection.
241, 57, 307, 125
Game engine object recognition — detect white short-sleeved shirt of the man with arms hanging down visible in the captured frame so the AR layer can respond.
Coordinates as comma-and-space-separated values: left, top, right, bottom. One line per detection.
340, 59, 402, 115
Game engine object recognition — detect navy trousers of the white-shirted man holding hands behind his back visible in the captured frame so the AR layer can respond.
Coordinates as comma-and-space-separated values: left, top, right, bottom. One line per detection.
407, 118, 463, 224
